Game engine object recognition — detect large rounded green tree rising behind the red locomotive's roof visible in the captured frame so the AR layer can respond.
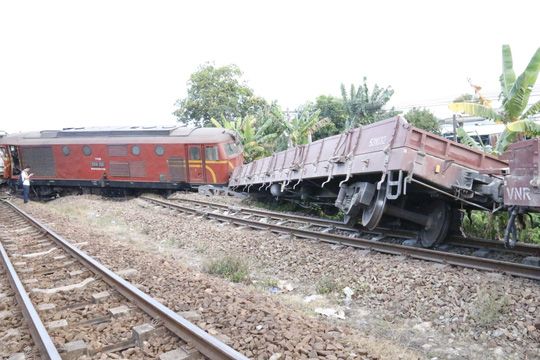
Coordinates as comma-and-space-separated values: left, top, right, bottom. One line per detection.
173, 62, 267, 126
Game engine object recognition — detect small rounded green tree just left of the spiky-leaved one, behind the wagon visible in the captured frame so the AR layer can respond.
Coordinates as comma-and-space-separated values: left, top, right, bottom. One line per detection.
313, 95, 347, 141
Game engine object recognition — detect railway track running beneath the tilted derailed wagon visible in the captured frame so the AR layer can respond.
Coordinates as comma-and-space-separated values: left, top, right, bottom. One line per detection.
141, 197, 540, 280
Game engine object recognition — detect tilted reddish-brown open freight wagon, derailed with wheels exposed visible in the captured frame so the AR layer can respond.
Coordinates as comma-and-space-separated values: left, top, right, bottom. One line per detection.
229, 116, 540, 247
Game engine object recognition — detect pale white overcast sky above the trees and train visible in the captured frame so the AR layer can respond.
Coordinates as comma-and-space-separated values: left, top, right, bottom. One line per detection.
0, 0, 540, 133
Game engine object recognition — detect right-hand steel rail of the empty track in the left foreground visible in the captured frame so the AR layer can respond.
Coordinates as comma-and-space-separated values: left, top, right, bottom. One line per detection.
6, 201, 248, 360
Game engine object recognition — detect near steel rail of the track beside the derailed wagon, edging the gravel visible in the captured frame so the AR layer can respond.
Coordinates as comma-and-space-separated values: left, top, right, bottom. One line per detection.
145, 198, 540, 280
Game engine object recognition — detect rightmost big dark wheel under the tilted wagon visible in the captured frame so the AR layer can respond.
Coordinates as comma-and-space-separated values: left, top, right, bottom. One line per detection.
420, 200, 452, 248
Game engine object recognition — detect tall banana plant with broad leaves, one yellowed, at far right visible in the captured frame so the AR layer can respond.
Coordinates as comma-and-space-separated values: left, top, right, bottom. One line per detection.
448, 45, 540, 153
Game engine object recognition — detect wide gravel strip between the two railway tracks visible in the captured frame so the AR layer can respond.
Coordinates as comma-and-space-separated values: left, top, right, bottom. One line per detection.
16, 194, 540, 359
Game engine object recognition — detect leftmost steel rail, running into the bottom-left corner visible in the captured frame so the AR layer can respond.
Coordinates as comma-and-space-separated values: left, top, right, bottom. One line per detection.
0, 214, 62, 360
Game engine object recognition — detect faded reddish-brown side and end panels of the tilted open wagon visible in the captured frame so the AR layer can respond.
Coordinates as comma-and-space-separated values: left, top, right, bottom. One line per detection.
229, 116, 508, 194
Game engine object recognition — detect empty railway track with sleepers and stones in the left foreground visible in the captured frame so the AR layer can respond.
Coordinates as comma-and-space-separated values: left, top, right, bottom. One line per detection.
0, 201, 247, 359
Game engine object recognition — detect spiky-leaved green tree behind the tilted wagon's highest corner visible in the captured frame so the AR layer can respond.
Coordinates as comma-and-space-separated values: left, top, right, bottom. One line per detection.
341, 77, 398, 129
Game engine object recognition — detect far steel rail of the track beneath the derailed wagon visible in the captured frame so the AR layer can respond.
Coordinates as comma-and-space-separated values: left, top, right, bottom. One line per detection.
165, 196, 540, 256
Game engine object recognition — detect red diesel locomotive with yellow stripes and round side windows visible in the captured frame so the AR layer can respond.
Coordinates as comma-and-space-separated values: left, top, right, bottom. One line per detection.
0, 125, 243, 197
